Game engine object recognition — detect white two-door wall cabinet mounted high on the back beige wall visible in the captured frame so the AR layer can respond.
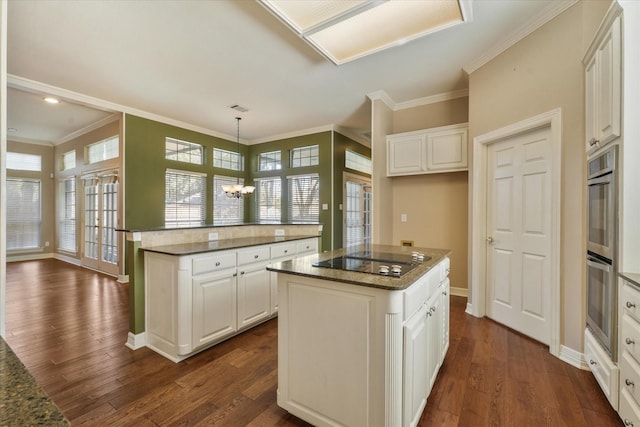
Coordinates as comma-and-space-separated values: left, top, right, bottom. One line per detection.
387, 123, 468, 176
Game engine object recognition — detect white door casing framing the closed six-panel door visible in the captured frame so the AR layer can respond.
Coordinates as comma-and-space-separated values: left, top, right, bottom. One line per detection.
467, 108, 560, 365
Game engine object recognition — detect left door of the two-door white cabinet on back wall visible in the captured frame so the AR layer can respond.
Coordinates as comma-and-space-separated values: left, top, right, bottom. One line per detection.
387, 134, 427, 175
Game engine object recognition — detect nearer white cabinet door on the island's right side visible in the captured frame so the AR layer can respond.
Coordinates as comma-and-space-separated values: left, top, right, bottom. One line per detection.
403, 305, 429, 426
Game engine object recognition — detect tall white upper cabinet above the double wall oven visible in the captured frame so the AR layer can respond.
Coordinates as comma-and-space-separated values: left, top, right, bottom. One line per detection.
583, 15, 622, 154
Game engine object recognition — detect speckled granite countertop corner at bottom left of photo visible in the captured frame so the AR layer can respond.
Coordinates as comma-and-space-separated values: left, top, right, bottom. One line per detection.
0, 338, 69, 427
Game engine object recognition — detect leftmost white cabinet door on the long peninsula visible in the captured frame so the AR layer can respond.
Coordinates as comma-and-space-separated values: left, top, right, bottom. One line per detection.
192, 270, 237, 349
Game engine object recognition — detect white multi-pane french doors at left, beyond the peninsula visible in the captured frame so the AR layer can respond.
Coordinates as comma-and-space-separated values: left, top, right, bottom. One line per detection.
82, 171, 121, 275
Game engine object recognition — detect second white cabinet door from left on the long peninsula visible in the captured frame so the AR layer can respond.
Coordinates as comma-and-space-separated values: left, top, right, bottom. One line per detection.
238, 264, 271, 329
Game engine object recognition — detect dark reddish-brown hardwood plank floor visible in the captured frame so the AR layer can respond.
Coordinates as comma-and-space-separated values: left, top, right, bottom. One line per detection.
6, 260, 622, 427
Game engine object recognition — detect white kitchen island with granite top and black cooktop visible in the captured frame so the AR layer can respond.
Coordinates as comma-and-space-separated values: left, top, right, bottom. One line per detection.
268, 245, 450, 426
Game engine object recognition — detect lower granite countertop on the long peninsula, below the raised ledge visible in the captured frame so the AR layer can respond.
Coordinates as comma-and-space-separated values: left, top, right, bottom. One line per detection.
140, 235, 319, 256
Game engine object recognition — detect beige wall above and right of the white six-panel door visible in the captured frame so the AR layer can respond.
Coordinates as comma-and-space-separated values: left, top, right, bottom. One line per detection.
469, 0, 609, 350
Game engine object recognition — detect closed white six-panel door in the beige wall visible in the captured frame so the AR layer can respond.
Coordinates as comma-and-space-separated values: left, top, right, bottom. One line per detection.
486, 127, 552, 344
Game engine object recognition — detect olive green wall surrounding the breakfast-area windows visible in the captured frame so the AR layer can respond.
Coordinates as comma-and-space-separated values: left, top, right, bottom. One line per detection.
124, 114, 371, 251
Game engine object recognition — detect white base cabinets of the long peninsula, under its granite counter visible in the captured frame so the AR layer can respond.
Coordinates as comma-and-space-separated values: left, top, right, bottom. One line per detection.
144, 238, 318, 362
